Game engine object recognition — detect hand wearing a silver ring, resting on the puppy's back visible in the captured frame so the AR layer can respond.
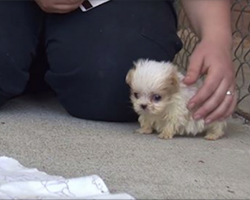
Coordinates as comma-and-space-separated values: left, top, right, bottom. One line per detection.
183, 40, 237, 124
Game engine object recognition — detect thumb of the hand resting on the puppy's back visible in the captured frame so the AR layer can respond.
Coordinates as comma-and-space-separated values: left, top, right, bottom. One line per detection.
183, 52, 203, 85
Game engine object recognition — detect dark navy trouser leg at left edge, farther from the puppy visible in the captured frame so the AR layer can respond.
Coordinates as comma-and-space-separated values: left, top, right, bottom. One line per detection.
0, 1, 42, 106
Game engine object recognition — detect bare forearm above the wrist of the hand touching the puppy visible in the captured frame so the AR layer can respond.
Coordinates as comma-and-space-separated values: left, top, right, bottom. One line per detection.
182, 0, 232, 47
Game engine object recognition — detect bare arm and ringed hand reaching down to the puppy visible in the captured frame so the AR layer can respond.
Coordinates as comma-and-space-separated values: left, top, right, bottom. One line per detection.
182, 0, 237, 123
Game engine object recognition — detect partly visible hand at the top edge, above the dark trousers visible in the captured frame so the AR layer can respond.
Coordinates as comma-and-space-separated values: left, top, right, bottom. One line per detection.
35, 0, 84, 14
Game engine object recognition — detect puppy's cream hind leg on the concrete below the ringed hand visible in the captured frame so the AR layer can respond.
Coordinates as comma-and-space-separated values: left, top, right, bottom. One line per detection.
205, 121, 226, 140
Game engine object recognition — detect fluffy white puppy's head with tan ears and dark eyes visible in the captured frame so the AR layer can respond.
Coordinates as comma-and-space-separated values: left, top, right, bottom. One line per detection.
126, 59, 179, 115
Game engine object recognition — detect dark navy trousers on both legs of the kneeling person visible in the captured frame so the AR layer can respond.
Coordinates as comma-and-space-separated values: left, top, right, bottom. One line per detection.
0, 0, 182, 122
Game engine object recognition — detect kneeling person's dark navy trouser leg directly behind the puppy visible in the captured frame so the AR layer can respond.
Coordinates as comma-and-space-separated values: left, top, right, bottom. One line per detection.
45, 0, 181, 122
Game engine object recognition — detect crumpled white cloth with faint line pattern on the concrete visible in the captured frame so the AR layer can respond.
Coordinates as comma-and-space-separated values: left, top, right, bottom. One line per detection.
0, 157, 134, 199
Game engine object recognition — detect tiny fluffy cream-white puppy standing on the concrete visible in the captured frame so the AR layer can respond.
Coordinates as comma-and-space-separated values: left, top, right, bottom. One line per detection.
126, 59, 226, 140
